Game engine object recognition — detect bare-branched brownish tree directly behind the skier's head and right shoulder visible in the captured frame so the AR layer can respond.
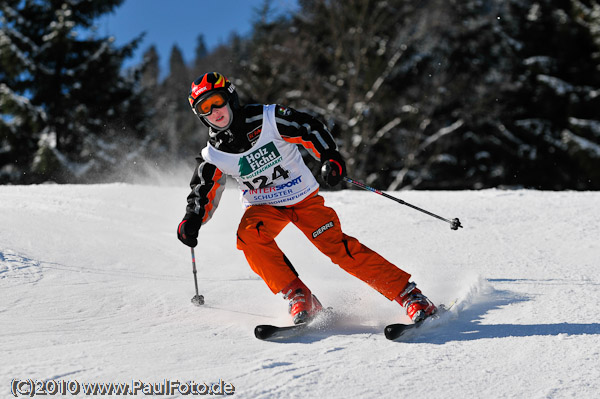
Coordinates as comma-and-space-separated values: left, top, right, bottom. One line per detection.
244, 0, 411, 182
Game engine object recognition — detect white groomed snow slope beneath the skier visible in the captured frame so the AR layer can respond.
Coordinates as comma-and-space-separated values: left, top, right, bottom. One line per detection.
0, 178, 600, 398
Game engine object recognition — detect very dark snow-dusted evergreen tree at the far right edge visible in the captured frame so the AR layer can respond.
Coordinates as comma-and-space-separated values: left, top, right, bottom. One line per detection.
506, 0, 600, 189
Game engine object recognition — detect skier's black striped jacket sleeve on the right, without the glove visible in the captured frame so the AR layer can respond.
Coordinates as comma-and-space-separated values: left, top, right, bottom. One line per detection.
275, 105, 338, 161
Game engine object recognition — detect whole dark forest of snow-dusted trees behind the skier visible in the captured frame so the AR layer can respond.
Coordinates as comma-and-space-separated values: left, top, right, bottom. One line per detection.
0, 0, 600, 190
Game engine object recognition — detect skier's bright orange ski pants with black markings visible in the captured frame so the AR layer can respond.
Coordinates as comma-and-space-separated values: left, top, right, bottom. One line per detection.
237, 195, 410, 300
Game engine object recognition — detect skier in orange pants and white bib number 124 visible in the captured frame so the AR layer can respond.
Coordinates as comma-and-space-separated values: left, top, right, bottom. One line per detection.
177, 72, 436, 324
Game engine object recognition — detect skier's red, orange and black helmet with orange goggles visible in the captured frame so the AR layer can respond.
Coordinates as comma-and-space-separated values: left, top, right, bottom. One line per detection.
188, 72, 239, 130
